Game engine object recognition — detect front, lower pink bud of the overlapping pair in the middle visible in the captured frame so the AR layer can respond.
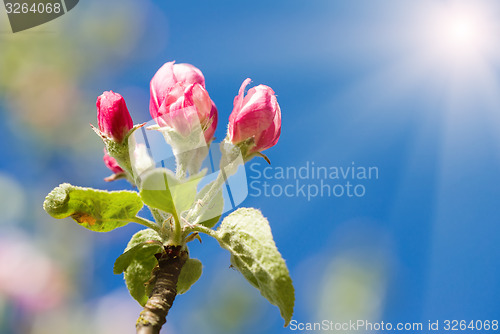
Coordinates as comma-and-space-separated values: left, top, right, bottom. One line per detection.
151, 82, 217, 143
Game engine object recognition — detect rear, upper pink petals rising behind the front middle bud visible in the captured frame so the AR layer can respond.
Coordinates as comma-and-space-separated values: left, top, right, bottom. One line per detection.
149, 61, 205, 119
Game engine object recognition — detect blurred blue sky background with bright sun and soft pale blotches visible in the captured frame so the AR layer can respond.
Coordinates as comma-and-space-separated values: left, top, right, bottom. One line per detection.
0, 0, 500, 334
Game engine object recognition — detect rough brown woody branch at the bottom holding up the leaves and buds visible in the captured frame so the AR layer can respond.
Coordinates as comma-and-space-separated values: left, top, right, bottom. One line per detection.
136, 246, 188, 334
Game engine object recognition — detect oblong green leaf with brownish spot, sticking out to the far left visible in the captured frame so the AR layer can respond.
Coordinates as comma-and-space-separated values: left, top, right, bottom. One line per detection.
43, 183, 144, 232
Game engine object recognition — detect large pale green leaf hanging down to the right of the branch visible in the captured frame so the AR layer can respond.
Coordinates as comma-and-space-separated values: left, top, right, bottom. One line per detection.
216, 208, 295, 326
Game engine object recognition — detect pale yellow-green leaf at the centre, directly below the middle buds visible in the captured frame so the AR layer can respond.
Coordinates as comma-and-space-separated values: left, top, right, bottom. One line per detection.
140, 168, 205, 218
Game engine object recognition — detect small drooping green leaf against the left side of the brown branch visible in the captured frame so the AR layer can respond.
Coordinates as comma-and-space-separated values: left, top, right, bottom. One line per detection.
120, 229, 162, 306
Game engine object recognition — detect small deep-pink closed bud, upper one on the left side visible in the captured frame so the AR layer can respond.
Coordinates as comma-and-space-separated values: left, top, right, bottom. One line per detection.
96, 91, 134, 142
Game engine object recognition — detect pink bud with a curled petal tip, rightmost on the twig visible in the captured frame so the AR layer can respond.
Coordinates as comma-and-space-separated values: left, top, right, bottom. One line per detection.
228, 79, 281, 153
